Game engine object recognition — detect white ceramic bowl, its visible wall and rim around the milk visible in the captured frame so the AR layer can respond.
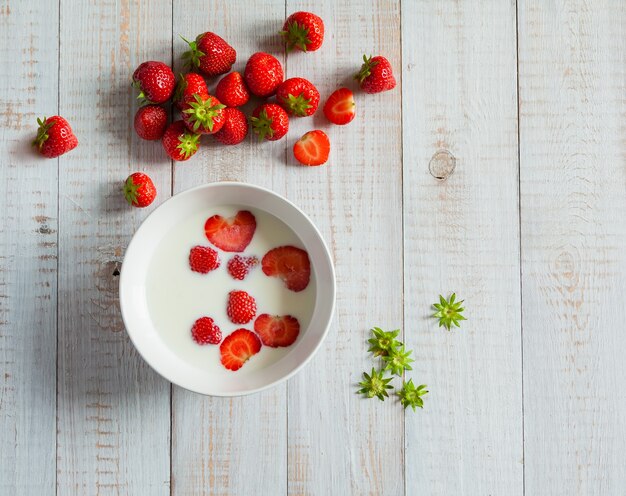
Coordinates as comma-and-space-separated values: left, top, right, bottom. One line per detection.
120, 182, 335, 396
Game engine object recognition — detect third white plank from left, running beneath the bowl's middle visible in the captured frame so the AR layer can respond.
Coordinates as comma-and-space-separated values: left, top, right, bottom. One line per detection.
172, 0, 289, 496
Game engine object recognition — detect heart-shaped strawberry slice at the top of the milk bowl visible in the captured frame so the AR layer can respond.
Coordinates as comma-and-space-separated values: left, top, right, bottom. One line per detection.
204, 210, 256, 252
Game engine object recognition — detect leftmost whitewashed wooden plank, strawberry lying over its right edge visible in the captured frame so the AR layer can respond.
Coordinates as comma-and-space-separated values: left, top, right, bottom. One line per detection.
0, 1, 58, 496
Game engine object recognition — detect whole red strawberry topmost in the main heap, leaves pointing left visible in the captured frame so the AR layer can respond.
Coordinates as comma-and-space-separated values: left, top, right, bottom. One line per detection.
183, 32, 237, 76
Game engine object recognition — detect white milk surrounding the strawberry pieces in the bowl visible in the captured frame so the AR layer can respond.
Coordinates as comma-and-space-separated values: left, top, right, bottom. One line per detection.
146, 205, 315, 374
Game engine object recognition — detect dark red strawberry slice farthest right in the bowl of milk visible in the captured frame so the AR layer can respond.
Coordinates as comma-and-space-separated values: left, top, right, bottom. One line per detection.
261, 246, 311, 292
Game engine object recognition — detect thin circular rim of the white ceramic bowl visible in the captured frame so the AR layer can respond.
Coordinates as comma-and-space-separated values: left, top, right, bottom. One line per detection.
118, 181, 337, 397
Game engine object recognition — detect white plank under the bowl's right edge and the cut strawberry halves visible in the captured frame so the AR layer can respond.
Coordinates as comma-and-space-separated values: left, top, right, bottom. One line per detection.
286, 0, 404, 495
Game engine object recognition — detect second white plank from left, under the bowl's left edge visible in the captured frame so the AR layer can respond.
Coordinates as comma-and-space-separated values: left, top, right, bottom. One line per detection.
57, 0, 171, 496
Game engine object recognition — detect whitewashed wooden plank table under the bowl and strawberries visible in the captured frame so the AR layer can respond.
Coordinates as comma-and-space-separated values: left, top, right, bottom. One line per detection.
0, 0, 626, 496
